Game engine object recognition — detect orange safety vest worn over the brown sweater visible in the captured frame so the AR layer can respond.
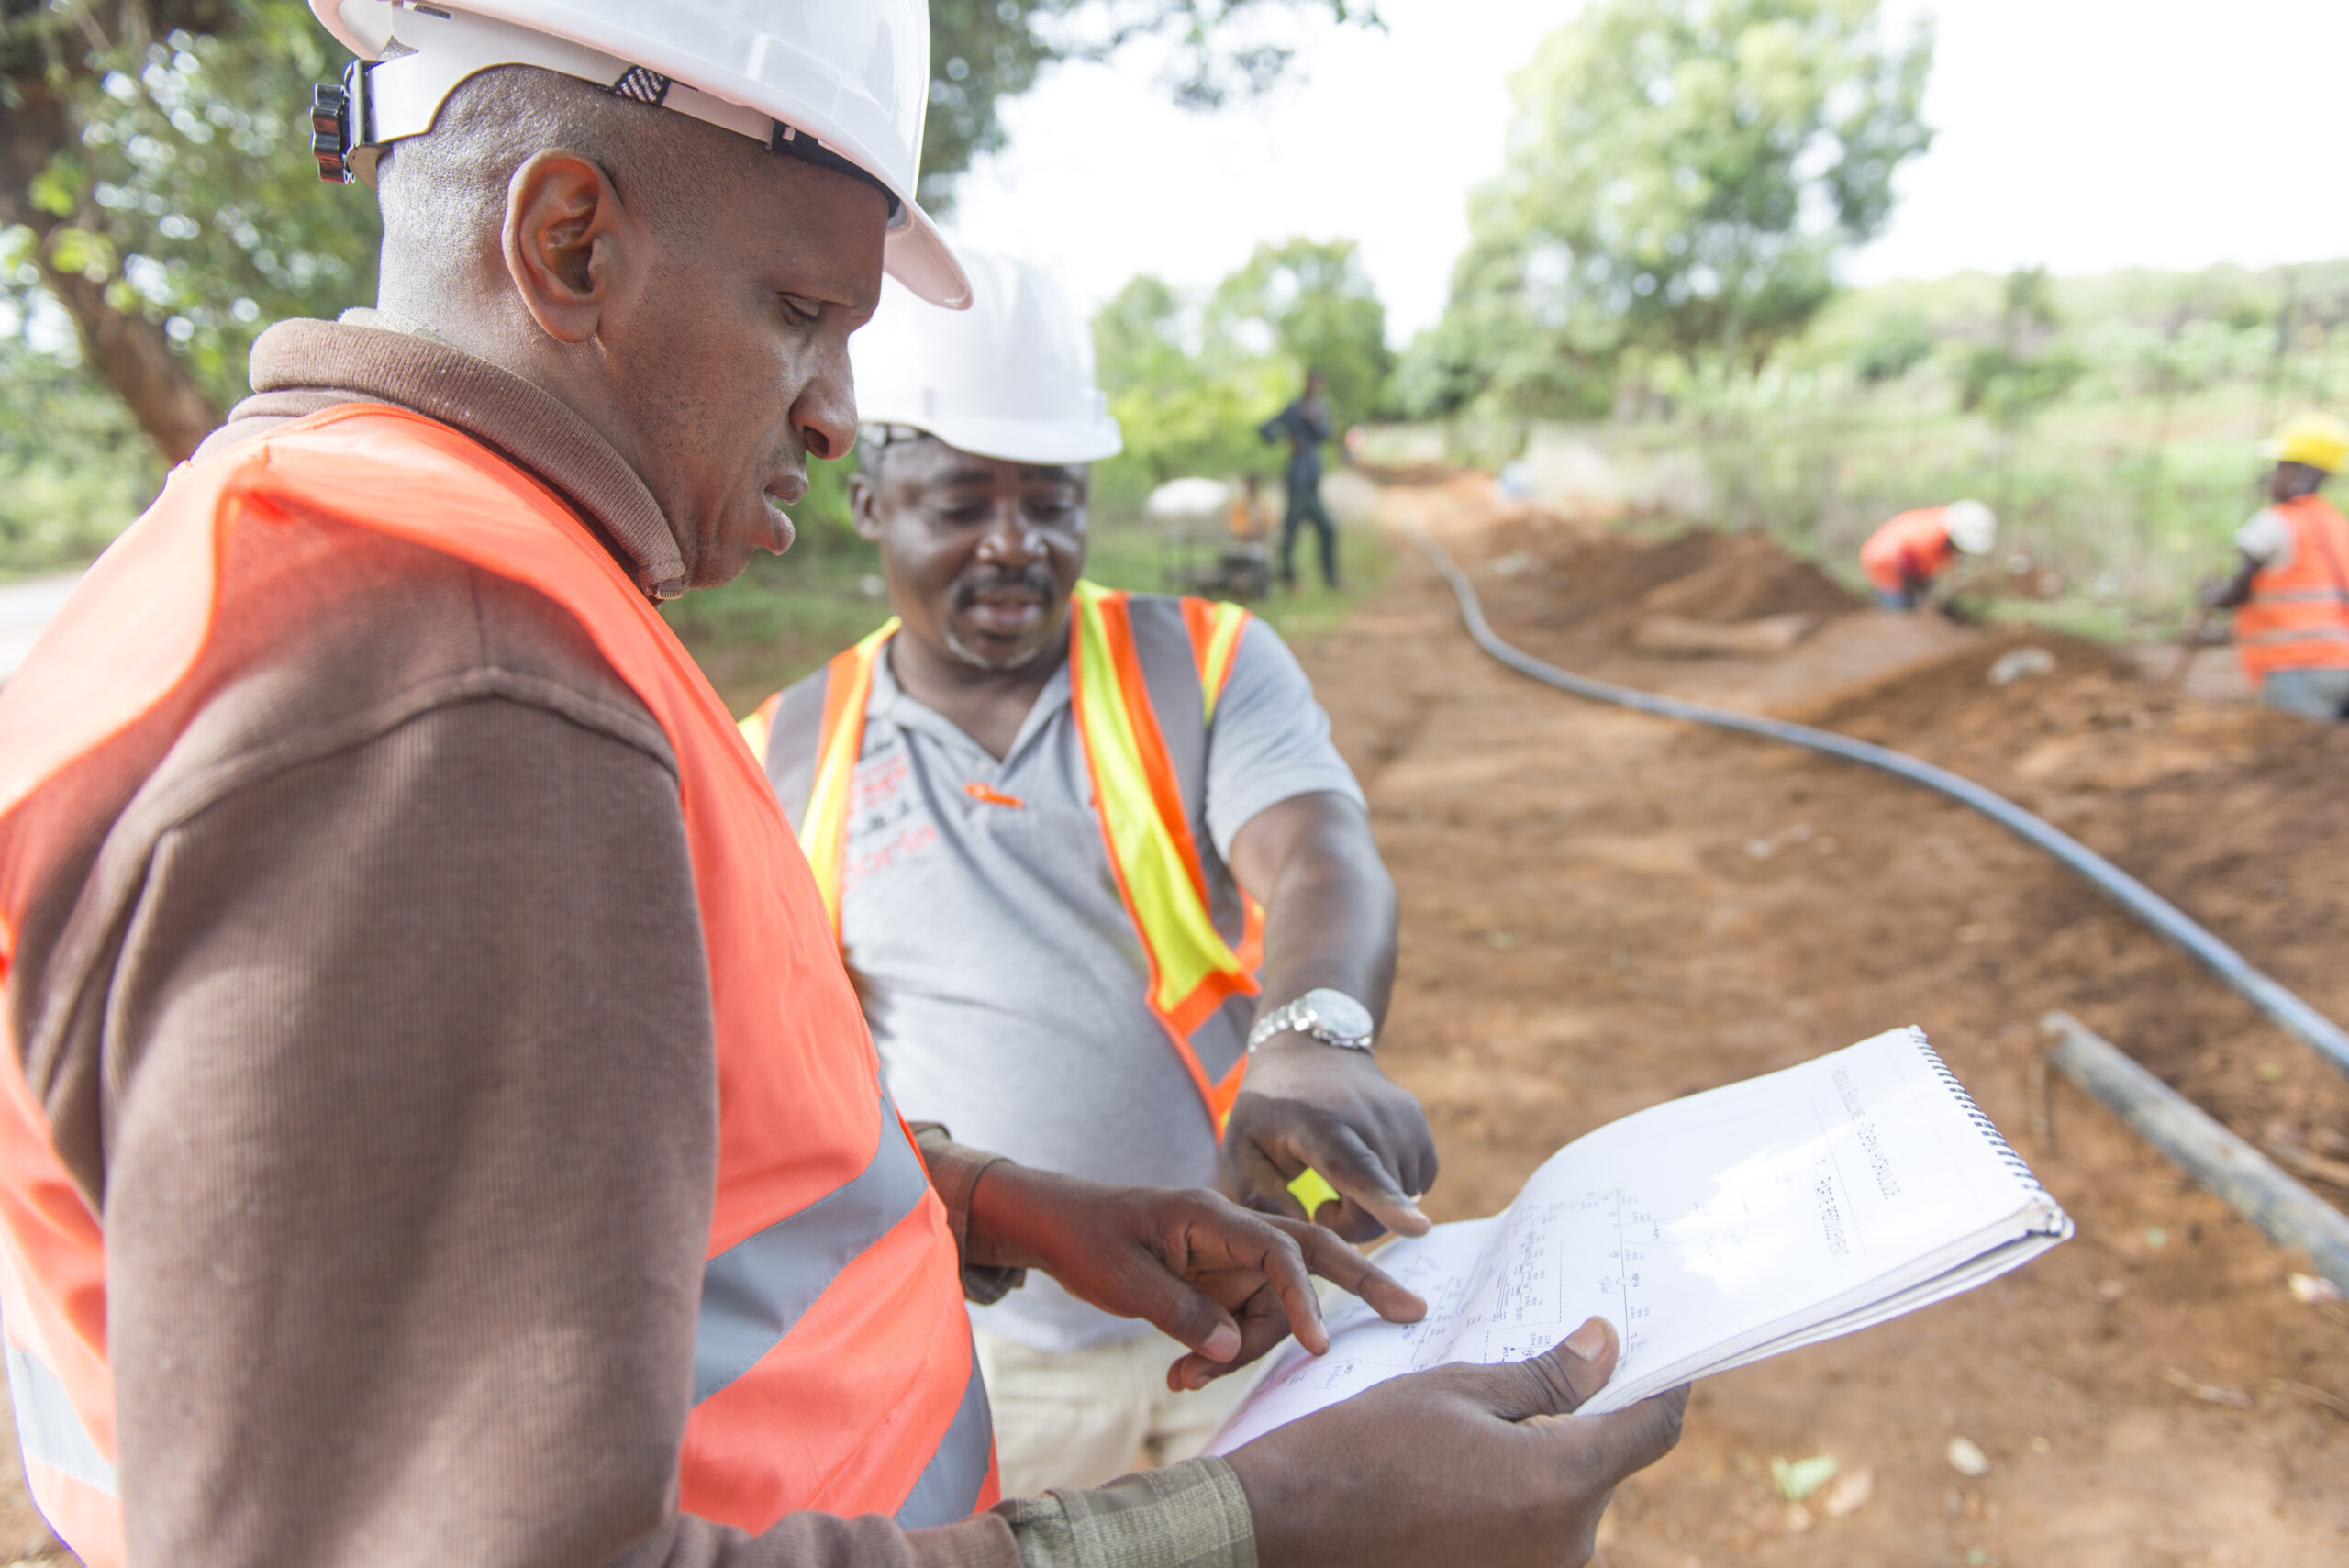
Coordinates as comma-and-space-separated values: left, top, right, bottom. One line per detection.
0, 404, 996, 1568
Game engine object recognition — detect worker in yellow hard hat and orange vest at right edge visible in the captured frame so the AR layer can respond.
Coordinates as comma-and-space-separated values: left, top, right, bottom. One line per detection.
2203, 416, 2349, 718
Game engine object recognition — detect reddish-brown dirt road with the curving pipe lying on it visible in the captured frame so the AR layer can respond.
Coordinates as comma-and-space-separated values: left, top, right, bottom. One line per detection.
1304, 493, 2349, 1568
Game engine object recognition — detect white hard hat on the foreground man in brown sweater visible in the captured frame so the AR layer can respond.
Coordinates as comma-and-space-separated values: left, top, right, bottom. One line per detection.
310, 0, 970, 310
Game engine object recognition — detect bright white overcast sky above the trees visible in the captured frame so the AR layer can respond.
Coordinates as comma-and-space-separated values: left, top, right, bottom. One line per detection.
956, 0, 2349, 343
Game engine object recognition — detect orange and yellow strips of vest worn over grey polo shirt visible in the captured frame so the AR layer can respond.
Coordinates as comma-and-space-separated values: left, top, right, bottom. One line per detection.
742, 582, 1264, 1139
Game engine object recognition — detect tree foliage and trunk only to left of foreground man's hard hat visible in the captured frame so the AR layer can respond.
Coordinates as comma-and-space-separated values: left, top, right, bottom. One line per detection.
0, 0, 342, 462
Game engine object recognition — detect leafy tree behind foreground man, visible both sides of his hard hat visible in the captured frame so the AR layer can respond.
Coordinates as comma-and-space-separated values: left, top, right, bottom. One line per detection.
0, 0, 1376, 484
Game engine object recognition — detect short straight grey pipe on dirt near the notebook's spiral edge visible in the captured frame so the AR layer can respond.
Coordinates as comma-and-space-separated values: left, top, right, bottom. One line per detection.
2039, 1012, 2349, 1291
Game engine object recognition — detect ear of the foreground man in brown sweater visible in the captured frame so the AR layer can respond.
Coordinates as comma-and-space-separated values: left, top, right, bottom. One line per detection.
500, 150, 651, 343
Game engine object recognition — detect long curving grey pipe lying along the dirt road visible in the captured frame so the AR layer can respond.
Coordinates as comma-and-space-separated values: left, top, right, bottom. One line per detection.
1407, 528, 2349, 1073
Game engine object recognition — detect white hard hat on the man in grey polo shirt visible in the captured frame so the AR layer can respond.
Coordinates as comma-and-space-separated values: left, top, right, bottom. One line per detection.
848, 244, 1125, 462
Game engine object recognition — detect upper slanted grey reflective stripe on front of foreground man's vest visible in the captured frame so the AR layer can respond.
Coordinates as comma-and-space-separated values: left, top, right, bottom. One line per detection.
693, 1096, 930, 1404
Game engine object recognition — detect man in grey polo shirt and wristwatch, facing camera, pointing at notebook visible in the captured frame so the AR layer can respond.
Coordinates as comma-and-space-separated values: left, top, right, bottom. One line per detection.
745, 247, 1435, 1491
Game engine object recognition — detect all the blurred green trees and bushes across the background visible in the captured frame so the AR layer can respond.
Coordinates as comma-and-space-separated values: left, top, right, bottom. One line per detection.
0, 0, 2349, 648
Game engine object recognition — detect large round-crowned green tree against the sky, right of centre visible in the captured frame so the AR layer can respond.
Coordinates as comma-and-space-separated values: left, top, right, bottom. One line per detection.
1412, 0, 1933, 406
